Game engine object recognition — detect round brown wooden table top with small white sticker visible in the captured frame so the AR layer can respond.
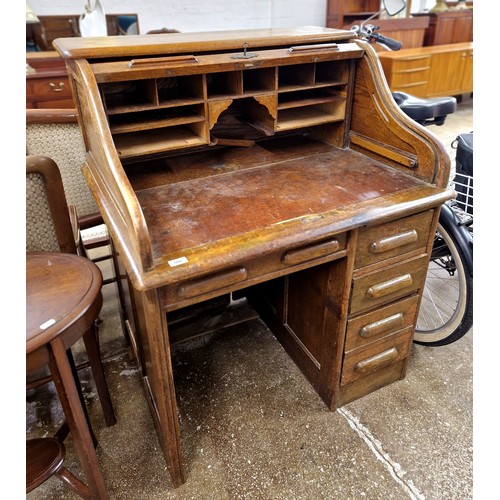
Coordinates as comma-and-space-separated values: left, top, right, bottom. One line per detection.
26, 252, 102, 354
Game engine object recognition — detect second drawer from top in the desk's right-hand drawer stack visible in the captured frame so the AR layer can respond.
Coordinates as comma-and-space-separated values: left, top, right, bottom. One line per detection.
350, 255, 428, 314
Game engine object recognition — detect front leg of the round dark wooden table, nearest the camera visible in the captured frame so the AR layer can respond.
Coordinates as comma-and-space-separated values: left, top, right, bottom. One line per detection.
49, 338, 109, 500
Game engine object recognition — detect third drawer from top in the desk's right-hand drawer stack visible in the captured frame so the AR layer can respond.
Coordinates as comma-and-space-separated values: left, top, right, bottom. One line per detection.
344, 295, 418, 355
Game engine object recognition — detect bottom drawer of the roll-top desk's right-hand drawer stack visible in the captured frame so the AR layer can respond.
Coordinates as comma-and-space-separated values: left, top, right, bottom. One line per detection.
341, 327, 413, 385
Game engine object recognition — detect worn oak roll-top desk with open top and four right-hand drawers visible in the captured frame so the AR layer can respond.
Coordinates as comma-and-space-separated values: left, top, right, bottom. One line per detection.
54, 27, 453, 486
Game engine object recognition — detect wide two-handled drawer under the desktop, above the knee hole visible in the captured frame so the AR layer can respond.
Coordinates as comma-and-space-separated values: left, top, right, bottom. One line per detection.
164, 233, 347, 310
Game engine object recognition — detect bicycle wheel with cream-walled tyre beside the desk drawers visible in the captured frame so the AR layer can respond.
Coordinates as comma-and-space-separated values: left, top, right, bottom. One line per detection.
414, 222, 473, 346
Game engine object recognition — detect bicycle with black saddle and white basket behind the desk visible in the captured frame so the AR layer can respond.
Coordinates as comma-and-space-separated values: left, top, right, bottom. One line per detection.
351, 3, 473, 347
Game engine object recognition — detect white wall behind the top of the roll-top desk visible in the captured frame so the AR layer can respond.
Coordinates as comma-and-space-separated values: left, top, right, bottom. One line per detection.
28, 0, 327, 33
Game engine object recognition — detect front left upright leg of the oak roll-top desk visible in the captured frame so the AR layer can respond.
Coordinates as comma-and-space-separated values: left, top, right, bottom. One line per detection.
141, 291, 184, 488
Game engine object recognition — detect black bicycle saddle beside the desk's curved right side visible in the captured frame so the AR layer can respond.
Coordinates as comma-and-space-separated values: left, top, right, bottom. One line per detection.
392, 92, 457, 125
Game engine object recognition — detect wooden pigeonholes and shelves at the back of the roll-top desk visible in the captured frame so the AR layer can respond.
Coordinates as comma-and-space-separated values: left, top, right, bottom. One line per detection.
95, 51, 351, 159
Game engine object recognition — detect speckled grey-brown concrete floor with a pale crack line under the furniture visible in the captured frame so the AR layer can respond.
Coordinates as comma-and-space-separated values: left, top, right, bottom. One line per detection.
26, 95, 473, 500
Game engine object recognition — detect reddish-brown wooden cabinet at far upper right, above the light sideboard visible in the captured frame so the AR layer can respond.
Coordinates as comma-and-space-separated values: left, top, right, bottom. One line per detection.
415, 9, 474, 46
